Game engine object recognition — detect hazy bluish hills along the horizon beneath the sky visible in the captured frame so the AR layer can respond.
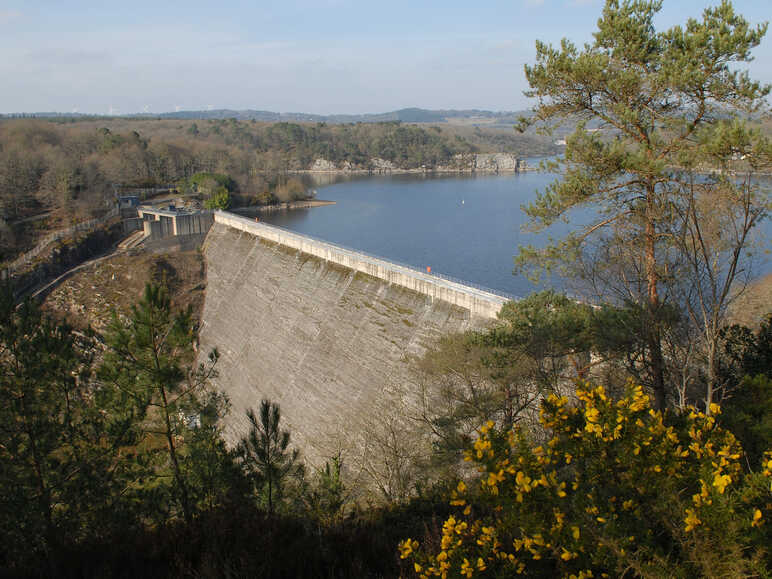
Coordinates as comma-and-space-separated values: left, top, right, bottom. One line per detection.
0, 108, 529, 125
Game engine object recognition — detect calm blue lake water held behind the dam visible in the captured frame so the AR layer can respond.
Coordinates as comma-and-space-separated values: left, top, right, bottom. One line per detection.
261, 172, 769, 296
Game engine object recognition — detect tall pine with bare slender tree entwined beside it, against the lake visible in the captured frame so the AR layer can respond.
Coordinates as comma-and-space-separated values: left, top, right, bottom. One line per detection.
518, 0, 770, 409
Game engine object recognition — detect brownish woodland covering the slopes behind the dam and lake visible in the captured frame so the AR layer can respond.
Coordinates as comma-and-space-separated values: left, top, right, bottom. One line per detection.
0, 118, 552, 259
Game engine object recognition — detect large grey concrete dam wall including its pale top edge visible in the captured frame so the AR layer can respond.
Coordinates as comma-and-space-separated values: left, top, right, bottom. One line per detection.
199, 212, 507, 464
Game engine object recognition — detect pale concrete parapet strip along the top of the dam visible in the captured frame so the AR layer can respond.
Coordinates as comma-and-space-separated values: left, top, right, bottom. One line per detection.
214, 211, 517, 318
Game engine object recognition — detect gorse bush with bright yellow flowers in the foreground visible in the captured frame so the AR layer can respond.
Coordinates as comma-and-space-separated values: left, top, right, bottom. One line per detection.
400, 384, 772, 578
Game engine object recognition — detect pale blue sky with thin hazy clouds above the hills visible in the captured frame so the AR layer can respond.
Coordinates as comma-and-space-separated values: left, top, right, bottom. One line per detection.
0, 0, 772, 114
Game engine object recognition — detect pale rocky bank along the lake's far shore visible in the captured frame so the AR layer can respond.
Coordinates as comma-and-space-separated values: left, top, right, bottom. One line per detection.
307, 153, 532, 173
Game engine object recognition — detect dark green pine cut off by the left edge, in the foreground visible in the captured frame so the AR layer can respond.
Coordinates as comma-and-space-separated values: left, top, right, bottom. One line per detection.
0, 291, 132, 566
